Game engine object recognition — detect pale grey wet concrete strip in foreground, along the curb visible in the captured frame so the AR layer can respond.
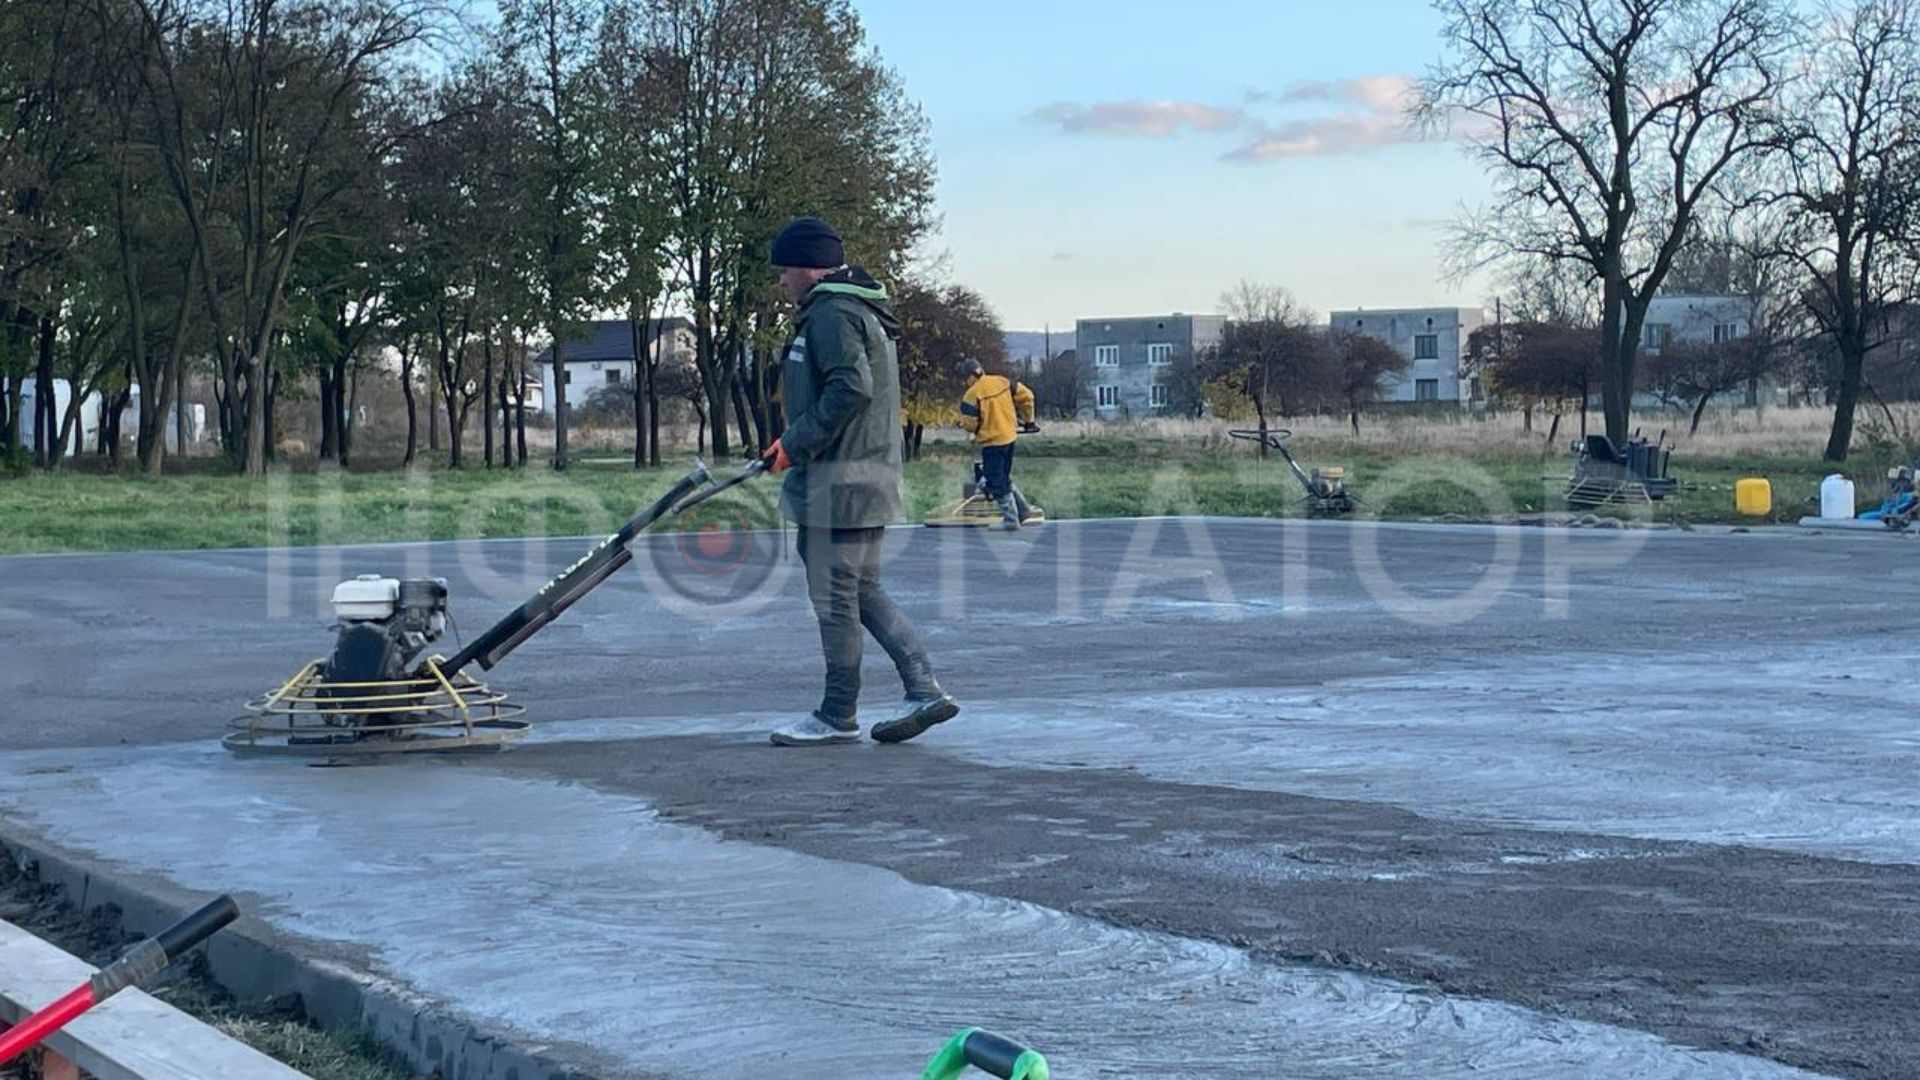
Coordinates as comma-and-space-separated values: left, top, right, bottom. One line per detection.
0, 748, 1835, 1078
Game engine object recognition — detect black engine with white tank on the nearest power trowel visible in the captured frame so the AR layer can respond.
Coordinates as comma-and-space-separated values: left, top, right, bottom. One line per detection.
323, 575, 447, 684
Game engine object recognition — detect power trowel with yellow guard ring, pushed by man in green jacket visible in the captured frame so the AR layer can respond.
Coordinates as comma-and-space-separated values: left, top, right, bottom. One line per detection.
221, 459, 768, 761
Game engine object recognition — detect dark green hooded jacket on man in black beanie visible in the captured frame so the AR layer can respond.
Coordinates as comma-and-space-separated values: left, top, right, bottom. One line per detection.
780, 267, 900, 528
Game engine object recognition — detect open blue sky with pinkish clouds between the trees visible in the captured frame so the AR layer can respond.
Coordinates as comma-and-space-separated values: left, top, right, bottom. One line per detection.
854, 0, 1488, 329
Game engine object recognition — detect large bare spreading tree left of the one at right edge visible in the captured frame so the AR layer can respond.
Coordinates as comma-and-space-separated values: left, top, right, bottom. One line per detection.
1421, 0, 1791, 442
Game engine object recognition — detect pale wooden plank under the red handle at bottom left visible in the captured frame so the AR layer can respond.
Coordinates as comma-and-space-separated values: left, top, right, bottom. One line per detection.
0, 922, 311, 1080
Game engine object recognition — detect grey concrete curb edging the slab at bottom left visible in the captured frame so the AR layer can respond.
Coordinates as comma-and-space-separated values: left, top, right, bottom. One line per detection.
0, 822, 595, 1080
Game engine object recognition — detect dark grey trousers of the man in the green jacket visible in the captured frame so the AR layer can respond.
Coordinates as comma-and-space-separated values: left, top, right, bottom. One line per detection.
801, 525, 941, 728
